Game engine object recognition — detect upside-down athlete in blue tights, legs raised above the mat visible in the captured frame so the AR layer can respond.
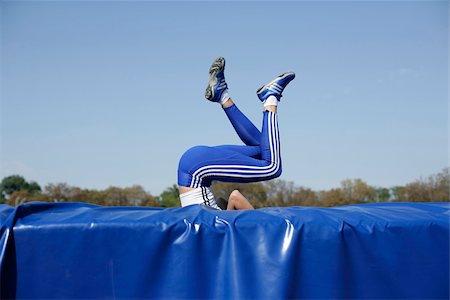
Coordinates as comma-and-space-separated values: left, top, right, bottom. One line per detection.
178, 59, 295, 208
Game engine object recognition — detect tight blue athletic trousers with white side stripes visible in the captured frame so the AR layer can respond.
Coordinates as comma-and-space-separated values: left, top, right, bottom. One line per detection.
178, 105, 281, 188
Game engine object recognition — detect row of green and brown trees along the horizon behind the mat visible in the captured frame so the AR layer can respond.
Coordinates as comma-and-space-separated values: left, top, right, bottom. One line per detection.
0, 168, 450, 208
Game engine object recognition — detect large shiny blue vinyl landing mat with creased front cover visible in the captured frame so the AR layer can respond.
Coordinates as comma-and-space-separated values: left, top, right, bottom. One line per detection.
0, 203, 450, 299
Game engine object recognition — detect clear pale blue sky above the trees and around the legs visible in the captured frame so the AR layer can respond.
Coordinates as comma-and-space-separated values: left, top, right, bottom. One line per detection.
0, 1, 449, 195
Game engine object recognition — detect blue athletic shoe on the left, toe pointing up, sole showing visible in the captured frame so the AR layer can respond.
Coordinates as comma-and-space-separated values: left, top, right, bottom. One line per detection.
205, 57, 227, 102
